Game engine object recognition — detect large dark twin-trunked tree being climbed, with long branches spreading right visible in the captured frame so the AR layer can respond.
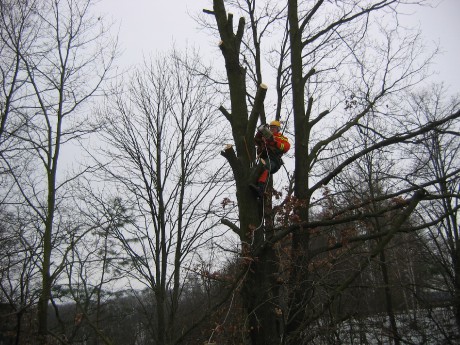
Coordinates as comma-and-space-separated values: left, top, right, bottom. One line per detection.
201, 0, 460, 344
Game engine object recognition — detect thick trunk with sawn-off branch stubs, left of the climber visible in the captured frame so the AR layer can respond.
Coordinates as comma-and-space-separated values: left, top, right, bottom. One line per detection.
213, 0, 280, 345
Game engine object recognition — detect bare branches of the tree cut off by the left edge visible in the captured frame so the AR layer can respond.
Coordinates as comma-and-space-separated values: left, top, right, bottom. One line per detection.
0, 0, 40, 224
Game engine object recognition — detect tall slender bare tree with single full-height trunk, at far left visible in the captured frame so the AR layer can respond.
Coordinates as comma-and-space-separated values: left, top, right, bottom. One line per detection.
2, 0, 115, 343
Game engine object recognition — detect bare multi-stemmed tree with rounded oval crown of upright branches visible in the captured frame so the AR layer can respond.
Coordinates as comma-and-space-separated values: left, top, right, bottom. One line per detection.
99, 52, 232, 344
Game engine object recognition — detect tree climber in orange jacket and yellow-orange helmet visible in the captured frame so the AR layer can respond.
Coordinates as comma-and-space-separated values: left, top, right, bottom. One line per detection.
249, 121, 291, 198
